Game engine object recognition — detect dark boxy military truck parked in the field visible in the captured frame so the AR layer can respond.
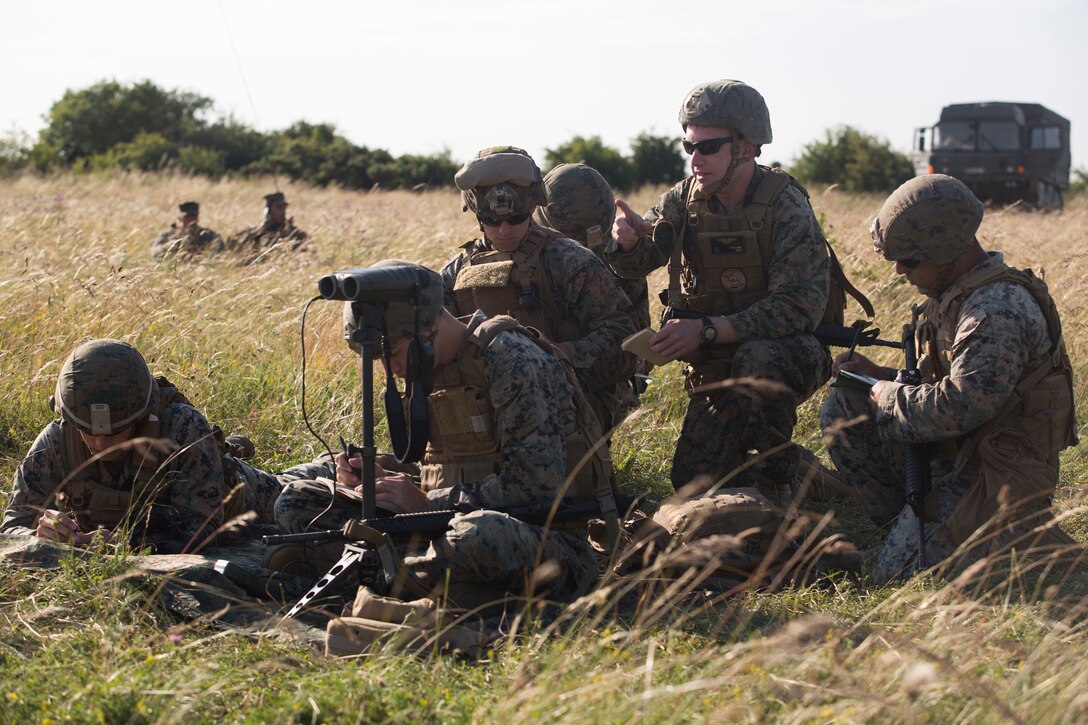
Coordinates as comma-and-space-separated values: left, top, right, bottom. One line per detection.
911, 101, 1070, 209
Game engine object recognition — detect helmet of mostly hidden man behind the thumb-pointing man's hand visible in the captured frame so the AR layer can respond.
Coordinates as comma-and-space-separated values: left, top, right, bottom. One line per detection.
536, 163, 616, 248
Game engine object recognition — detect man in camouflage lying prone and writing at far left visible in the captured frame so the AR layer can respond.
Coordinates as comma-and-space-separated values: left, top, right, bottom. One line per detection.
0, 340, 289, 554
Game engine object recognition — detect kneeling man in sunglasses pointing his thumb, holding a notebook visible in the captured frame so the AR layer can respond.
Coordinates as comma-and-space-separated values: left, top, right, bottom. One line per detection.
605, 81, 841, 496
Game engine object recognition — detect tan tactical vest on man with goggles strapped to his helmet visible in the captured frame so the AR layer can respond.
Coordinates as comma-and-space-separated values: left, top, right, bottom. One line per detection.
454, 224, 582, 342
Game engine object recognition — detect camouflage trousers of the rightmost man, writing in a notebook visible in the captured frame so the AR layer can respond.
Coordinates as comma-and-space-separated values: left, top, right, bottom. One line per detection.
820, 388, 978, 582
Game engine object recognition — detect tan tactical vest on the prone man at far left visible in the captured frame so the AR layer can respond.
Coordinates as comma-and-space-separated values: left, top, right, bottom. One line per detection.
57, 376, 246, 530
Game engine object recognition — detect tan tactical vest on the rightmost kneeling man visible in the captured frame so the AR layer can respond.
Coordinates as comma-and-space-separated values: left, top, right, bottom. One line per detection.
915, 265, 1077, 469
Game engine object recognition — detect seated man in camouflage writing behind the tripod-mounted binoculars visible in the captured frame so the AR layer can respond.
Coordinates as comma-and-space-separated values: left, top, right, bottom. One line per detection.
275, 260, 611, 598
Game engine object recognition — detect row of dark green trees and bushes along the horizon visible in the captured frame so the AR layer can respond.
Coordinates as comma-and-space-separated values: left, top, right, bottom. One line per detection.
0, 81, 931, 192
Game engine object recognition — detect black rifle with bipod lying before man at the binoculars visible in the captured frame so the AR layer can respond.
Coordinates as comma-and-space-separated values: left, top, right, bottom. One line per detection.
262, 494, 645, 618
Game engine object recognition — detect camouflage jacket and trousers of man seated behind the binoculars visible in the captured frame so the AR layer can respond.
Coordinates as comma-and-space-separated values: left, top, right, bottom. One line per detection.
275, 315, 597, 597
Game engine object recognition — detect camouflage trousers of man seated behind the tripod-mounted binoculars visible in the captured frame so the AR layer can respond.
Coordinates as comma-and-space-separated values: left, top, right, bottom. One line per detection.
275, 481, 597, 599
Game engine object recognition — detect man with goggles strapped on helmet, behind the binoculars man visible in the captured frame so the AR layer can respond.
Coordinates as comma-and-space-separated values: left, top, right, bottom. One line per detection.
442, 147, 636, 431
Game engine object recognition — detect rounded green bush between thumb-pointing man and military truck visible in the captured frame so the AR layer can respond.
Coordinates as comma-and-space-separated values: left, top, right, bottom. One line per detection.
790, 126, 914, 192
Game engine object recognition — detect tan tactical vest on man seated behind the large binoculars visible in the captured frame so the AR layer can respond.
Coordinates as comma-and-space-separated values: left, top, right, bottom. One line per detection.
420, 316, 616, 535
